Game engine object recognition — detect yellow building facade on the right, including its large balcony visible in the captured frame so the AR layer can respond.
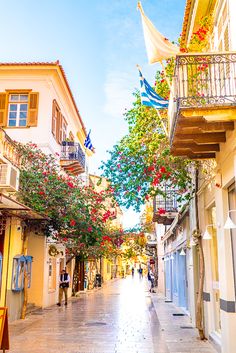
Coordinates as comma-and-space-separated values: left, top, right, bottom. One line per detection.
169, 0, 236, 353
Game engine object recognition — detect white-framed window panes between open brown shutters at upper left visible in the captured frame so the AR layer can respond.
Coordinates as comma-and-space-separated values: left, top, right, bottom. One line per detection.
8, 94, 28, 127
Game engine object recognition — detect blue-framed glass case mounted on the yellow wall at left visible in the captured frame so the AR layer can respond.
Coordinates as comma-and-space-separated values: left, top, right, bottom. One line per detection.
11, 255, 33, 292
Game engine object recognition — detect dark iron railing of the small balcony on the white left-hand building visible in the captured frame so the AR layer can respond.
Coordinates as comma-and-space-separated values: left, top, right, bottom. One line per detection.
60, 141, 85, 170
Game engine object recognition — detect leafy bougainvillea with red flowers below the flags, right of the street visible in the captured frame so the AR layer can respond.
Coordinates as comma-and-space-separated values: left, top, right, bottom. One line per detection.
101, 89, 192, 211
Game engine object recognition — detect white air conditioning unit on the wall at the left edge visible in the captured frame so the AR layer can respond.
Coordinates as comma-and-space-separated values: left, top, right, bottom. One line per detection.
0, 164, 20, 192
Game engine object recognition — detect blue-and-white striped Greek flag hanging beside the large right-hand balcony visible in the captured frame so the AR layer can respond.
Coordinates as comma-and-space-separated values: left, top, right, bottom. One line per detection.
139, 70, 169, 109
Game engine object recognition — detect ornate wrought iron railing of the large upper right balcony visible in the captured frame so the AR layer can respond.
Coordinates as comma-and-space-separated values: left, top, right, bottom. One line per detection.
175, 52, 236, 109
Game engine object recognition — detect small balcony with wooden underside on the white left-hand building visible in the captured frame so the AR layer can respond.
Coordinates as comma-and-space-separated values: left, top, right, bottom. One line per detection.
60, 141, 85, 175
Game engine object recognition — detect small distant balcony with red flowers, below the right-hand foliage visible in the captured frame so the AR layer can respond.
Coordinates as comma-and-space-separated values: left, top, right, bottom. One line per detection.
153, 190, 178, 225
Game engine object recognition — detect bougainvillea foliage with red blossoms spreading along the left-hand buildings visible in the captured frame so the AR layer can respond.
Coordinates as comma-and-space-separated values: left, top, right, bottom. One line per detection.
17, 143, 116, 256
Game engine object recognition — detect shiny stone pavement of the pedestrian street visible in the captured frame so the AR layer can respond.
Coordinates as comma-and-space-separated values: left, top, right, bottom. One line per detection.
10, 278, 216, 353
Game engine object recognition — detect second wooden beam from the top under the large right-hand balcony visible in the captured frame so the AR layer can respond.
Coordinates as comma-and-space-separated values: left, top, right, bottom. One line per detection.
173, 132, 226, 144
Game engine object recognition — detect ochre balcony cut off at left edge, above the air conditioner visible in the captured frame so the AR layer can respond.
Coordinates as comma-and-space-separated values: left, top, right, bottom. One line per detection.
0, 129, 21, 167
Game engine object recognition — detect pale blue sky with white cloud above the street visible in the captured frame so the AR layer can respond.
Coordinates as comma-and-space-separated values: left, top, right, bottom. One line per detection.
0, 0, 185, 226
